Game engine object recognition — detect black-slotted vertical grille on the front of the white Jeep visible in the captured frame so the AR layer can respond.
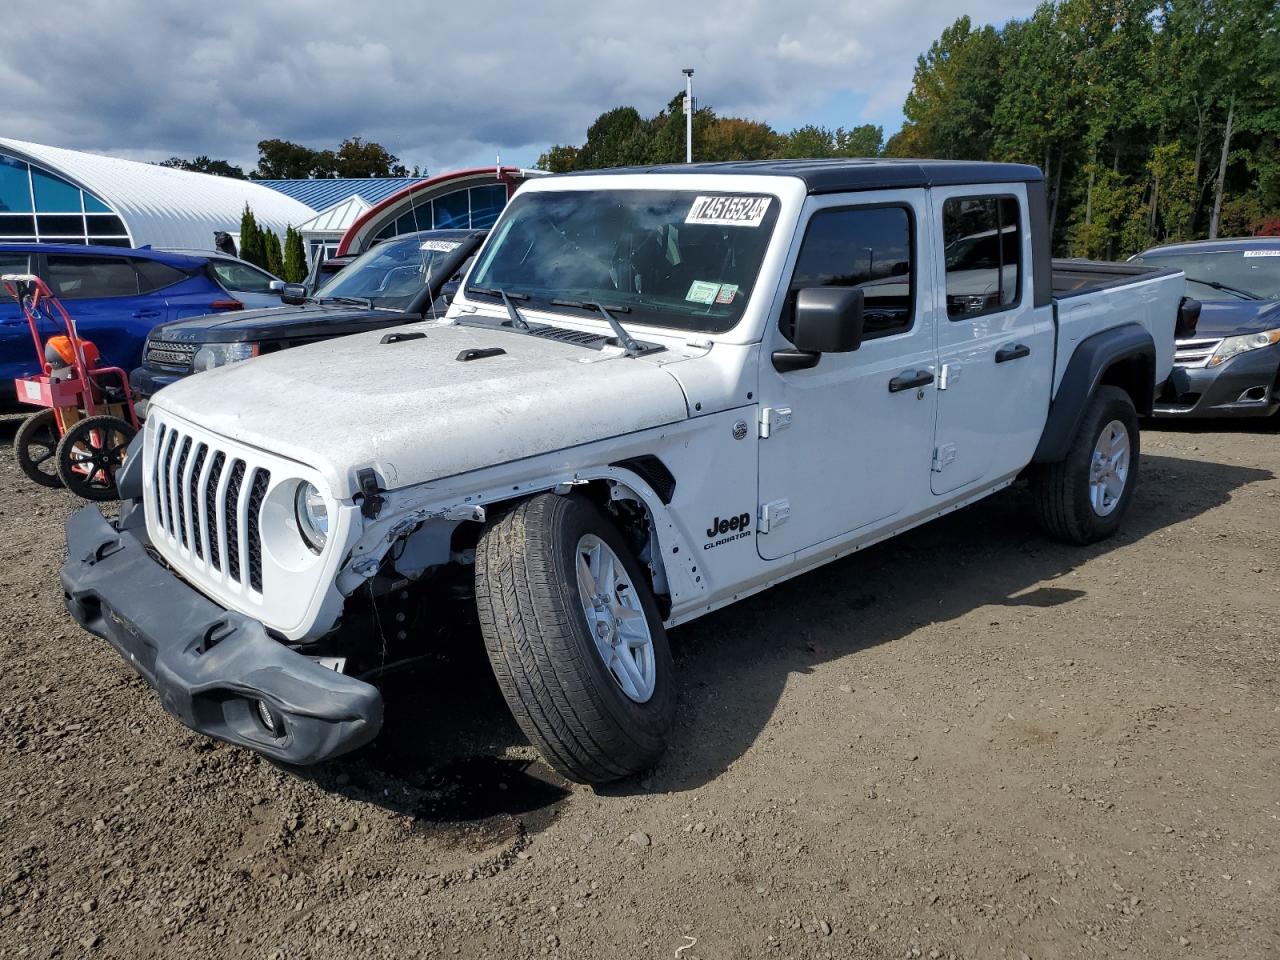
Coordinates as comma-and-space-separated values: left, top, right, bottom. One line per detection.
151, 424, 271, 593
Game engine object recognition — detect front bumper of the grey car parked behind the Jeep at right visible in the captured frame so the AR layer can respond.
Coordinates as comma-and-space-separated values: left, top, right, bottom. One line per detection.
1152, 346, 1280, 417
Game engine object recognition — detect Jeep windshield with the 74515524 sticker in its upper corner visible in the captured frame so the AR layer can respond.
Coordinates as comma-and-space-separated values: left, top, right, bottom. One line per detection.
467, 189, 780, 333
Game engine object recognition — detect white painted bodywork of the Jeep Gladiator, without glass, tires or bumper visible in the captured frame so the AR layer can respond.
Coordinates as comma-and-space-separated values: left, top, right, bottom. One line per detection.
147, 173, 1183, 639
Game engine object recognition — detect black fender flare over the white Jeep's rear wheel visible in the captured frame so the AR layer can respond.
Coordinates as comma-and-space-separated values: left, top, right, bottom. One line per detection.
1032, 323, 1156, 463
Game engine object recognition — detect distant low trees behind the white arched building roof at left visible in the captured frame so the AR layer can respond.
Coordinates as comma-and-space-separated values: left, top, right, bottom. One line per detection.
160, 137, 422, 180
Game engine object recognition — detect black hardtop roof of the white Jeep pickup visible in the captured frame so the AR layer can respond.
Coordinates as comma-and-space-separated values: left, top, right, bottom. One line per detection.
561, 157, 1044, 193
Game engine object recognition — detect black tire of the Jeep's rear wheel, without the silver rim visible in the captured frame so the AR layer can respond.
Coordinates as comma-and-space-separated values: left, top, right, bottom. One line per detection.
1032, 387, 1140, 544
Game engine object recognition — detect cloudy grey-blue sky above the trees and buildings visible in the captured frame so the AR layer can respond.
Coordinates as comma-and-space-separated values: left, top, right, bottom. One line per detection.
0, 0, 1034, 172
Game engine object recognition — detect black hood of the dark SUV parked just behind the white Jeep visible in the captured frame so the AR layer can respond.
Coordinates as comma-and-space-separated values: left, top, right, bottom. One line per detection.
151, 303, 420, 343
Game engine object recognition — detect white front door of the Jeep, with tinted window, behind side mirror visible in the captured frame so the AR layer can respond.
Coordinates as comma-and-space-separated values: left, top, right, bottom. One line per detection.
756, 189, 937, 559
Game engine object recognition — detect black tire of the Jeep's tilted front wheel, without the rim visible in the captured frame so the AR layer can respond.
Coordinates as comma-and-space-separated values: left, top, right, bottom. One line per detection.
475, 493, 676, 783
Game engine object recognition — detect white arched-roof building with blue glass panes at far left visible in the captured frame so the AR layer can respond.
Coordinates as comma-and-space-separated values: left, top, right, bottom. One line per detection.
0, 137, 315, 250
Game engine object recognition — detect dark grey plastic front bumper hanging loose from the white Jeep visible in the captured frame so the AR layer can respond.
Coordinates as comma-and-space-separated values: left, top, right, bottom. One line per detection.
61, 506, 383, 764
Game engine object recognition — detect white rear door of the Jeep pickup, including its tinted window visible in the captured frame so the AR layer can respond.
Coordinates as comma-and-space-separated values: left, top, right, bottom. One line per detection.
931, 183, 1055, 495
